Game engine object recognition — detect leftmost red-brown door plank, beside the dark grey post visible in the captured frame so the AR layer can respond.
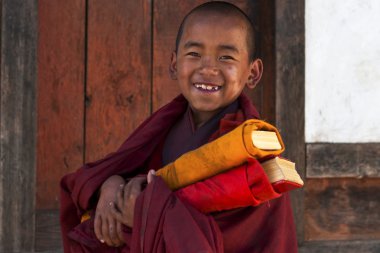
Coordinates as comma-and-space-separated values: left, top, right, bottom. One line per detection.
36, 0, 85, 209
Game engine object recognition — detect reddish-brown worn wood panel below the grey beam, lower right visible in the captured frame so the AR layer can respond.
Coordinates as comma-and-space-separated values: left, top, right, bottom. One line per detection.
305, 179, 380, 241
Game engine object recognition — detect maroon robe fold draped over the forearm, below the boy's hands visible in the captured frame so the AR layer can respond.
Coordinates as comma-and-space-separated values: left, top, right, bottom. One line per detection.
65, 177, 224, 253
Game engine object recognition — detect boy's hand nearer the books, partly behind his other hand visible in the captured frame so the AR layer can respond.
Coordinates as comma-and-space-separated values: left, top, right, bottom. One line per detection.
112, 171, 153, 228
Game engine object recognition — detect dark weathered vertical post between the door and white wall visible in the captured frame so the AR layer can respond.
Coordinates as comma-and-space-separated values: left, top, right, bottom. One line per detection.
275, 0, 305, 243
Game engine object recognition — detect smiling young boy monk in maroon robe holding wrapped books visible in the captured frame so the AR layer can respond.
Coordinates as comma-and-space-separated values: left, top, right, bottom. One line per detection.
61, 2, 297, 253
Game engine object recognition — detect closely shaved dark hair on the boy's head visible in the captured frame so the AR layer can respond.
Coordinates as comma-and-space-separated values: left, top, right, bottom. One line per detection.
175, 1, 255, 61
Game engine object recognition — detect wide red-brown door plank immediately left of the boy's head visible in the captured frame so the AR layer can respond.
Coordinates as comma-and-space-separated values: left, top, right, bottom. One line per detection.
86, 0, 151, 161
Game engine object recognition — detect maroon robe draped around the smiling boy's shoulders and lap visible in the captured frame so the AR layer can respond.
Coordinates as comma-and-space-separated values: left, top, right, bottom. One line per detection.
61, 95, 297, 253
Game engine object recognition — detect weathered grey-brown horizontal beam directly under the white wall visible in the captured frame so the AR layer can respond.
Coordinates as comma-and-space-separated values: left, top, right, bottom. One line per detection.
306, 143, 380, 178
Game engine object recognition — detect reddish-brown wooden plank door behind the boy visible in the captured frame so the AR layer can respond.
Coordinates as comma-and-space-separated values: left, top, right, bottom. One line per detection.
35, 0, 275, 251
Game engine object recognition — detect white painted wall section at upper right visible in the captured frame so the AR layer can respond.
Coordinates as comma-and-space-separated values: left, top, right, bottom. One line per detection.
305, 0, 380, 143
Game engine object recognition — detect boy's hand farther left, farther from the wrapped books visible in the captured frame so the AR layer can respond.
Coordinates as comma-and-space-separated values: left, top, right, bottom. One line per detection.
94, 176, 125, 247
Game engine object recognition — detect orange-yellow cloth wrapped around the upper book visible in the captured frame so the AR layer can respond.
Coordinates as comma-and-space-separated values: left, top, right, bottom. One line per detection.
156, 119, 285, 190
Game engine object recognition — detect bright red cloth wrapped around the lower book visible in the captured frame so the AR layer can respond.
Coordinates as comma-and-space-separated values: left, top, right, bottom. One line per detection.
175, 159, 281, 213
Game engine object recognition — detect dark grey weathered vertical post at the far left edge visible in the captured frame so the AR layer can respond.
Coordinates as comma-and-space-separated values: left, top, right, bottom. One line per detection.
0, 0, 37, 252
